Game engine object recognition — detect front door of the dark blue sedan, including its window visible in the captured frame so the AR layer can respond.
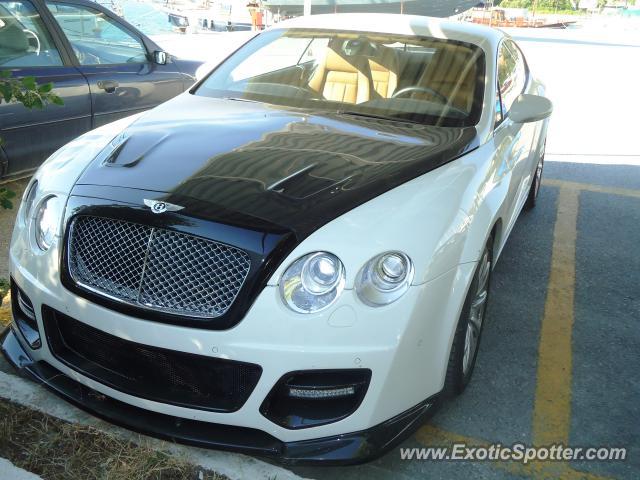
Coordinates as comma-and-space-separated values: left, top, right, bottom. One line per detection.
46, 1, 185, 127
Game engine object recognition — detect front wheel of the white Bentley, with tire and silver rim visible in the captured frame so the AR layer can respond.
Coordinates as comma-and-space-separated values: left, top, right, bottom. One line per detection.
444, 237, 493, 397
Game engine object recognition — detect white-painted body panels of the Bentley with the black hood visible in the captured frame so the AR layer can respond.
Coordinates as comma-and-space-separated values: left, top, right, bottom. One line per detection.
3, 14, 548, 464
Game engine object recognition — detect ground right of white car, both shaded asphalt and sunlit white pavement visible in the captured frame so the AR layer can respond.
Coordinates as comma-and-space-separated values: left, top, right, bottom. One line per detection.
0, 15, 640, 480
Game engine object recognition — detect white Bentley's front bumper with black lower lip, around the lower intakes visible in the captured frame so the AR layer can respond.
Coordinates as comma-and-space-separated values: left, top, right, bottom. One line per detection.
3, 202, 474, 463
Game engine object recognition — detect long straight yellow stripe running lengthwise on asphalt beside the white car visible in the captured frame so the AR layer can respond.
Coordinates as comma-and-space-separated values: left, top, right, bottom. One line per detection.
533, 186, 580, 445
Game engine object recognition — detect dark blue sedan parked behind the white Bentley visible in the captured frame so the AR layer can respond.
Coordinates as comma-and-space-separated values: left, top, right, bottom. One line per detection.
0, 0, 200, 177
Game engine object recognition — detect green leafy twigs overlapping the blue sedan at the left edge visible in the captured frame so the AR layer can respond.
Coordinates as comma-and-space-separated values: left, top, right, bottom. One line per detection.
0, 70, 63, 208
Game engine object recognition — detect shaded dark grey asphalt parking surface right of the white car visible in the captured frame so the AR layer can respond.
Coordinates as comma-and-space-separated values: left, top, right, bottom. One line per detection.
294, 158, 640, 480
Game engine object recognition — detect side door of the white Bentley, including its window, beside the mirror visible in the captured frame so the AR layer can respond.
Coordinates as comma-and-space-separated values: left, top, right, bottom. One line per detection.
494, 40, 535, 229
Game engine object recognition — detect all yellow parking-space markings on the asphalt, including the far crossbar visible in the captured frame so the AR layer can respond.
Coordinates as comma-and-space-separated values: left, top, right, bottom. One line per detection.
416, 180, 592, 480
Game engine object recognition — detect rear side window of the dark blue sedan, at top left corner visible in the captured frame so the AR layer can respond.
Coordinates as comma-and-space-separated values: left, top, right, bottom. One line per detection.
0, 0, 62, 68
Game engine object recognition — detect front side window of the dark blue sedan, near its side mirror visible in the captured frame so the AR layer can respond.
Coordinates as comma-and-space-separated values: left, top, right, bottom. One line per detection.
47, 2, 147, 65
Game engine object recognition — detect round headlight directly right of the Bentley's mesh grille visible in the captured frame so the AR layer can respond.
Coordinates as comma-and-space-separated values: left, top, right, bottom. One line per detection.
280, 252, 345, 313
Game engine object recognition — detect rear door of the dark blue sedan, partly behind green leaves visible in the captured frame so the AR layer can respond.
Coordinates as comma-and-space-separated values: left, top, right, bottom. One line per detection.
0, 0, 91, 176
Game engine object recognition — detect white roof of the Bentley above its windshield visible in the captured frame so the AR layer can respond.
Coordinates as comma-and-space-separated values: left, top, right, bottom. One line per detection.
271, 13, 505, 51
